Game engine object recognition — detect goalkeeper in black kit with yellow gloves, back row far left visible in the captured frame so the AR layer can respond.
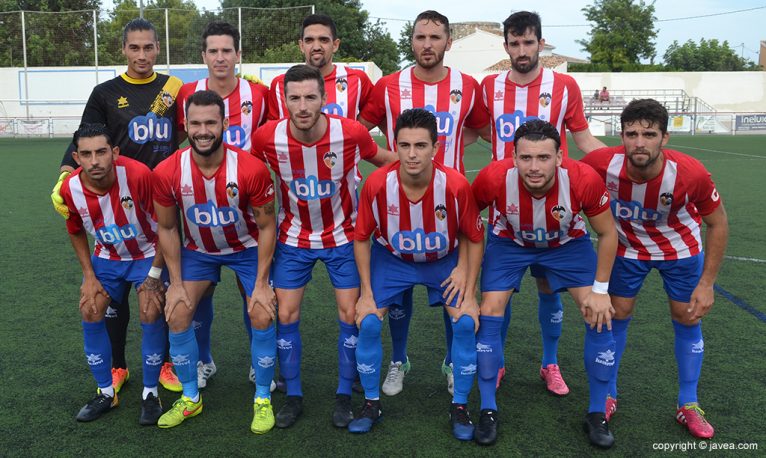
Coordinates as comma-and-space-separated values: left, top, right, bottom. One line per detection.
51, 19, 183, 391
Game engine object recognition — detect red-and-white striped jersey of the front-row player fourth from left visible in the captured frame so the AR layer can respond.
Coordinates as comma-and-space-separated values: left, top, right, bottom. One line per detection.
354, 161, 484, 262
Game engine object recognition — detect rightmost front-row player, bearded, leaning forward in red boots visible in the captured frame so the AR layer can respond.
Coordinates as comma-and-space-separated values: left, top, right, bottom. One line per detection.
583, 99, 729, 439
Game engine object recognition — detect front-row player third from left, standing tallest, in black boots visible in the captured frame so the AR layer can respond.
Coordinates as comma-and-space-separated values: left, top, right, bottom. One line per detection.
253, 65, 393, 432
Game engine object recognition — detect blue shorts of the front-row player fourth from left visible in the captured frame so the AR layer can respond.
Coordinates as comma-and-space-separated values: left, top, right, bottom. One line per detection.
370, 242, 457, 308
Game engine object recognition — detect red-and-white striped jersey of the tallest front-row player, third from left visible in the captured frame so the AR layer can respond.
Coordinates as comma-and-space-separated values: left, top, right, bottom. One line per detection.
252, 114, 378, 249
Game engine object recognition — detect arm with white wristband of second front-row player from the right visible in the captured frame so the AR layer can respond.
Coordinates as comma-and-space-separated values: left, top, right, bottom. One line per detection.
582, 209, 618, 332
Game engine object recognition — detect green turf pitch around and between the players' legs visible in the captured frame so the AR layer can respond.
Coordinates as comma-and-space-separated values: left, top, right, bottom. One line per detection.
0, 136, 766, 457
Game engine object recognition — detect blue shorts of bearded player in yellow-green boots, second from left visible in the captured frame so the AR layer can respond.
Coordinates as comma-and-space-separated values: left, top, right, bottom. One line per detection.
181, 247, 258, 297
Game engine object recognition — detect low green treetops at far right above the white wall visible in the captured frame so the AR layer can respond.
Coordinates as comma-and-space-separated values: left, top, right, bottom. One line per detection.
663, 38, 759, 72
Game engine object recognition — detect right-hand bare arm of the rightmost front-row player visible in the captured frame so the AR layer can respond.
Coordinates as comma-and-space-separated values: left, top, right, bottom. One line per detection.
688, 204, 729, 320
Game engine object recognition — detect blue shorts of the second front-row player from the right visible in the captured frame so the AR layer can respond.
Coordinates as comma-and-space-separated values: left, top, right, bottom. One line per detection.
481, 234, 596, 292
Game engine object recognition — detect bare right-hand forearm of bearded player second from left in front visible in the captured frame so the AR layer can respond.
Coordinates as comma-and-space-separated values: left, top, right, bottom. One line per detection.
249, 200, 277, 320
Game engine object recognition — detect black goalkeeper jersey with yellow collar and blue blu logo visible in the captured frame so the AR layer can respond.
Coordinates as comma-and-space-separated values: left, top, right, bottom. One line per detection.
61, 73, 183, 169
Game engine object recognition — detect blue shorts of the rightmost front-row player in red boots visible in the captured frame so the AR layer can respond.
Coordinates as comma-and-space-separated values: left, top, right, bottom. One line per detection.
609, 253, 705, 302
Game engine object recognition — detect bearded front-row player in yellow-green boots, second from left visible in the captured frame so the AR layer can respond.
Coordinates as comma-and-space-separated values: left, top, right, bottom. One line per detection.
154, 91, 276, 429
